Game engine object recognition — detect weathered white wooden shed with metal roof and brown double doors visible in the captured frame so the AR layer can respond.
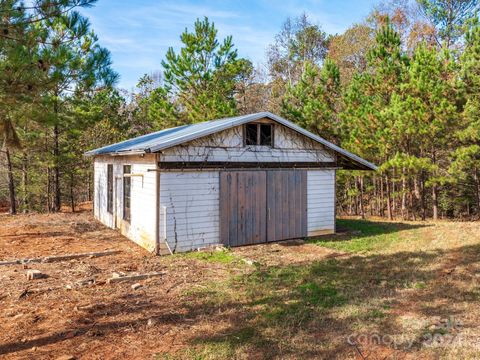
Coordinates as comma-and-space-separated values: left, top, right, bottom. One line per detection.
86, 112, 376, 254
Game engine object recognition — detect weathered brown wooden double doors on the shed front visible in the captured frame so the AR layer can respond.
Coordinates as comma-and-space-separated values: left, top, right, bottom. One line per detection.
220, 170, 307, 246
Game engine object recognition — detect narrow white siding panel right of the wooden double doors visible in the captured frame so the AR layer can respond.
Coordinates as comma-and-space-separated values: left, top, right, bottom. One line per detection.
307, 170, 335, 236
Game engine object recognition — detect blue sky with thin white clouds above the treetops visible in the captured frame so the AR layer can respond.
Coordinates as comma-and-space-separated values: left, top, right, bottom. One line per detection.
82, 0, 378, 90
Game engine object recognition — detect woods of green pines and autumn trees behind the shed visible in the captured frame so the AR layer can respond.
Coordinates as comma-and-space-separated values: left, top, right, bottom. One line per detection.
0, 0, 480, 219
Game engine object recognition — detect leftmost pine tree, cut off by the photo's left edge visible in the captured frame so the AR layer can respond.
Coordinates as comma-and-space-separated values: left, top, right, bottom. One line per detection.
0, 0, 100, 213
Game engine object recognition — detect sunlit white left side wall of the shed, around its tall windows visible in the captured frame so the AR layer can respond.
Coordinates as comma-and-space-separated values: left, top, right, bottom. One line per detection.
94, 155, 156, 251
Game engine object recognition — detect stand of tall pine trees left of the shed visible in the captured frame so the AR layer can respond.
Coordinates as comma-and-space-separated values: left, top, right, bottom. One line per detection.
0, 0, 118, 213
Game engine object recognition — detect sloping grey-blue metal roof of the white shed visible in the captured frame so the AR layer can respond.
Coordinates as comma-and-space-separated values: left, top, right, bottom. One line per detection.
85, 112, 377, 170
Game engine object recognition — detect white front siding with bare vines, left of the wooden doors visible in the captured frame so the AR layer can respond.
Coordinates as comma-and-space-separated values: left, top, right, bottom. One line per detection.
160, 171, 220, 252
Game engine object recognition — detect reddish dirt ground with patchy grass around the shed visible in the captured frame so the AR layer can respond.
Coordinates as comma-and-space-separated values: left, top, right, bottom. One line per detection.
0, 212, 480, 359
